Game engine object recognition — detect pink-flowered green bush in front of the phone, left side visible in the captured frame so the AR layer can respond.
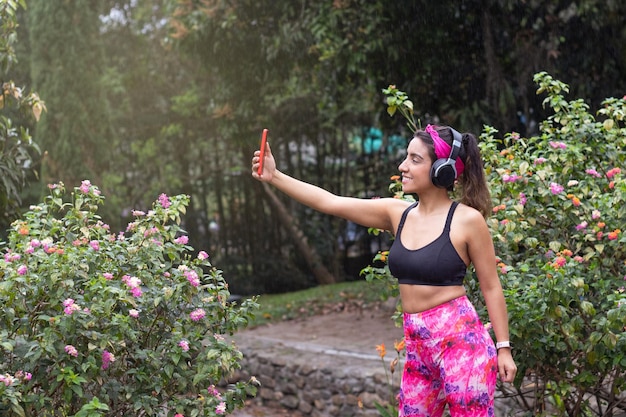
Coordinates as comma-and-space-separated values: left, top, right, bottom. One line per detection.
0, 181, 258, 417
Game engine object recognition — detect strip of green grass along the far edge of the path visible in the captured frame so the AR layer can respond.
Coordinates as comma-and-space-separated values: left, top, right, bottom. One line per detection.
245, 281, 385, 327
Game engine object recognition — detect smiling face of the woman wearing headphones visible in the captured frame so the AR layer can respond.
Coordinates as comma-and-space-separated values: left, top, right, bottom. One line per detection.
398, 138, 434, 193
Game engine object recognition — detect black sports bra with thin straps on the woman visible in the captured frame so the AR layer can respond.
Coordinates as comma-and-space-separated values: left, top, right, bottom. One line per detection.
388, 201, 467, 286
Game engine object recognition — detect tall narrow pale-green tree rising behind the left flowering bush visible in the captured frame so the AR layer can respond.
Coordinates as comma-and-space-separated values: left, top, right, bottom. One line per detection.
27, 0, 119, 197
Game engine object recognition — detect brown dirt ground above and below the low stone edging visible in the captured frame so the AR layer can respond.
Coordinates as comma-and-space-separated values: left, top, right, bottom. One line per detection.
231, 303, 402, 417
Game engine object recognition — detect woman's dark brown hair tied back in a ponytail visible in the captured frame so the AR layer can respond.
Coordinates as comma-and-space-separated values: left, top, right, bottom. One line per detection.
414, 126, 491, 218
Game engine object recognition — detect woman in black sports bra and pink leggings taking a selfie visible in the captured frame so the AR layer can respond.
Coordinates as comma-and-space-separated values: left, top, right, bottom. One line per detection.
252, 125, 517, 417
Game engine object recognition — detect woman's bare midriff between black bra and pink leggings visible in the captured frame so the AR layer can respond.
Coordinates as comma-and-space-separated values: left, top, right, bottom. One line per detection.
400, 284, 466, 313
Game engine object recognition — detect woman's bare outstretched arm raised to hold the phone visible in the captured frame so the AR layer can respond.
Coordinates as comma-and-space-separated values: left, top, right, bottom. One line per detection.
252, 143, 408, 231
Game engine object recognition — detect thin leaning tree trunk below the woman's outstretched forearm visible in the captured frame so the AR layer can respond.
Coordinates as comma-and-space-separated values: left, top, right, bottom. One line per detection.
263, 183, 337, 285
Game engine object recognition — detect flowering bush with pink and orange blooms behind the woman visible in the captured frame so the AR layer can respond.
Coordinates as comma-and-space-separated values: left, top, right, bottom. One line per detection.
370, 73, 626, 417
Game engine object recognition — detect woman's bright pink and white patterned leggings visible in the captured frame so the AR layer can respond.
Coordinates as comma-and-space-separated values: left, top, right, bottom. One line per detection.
398, 296, 498, 417
